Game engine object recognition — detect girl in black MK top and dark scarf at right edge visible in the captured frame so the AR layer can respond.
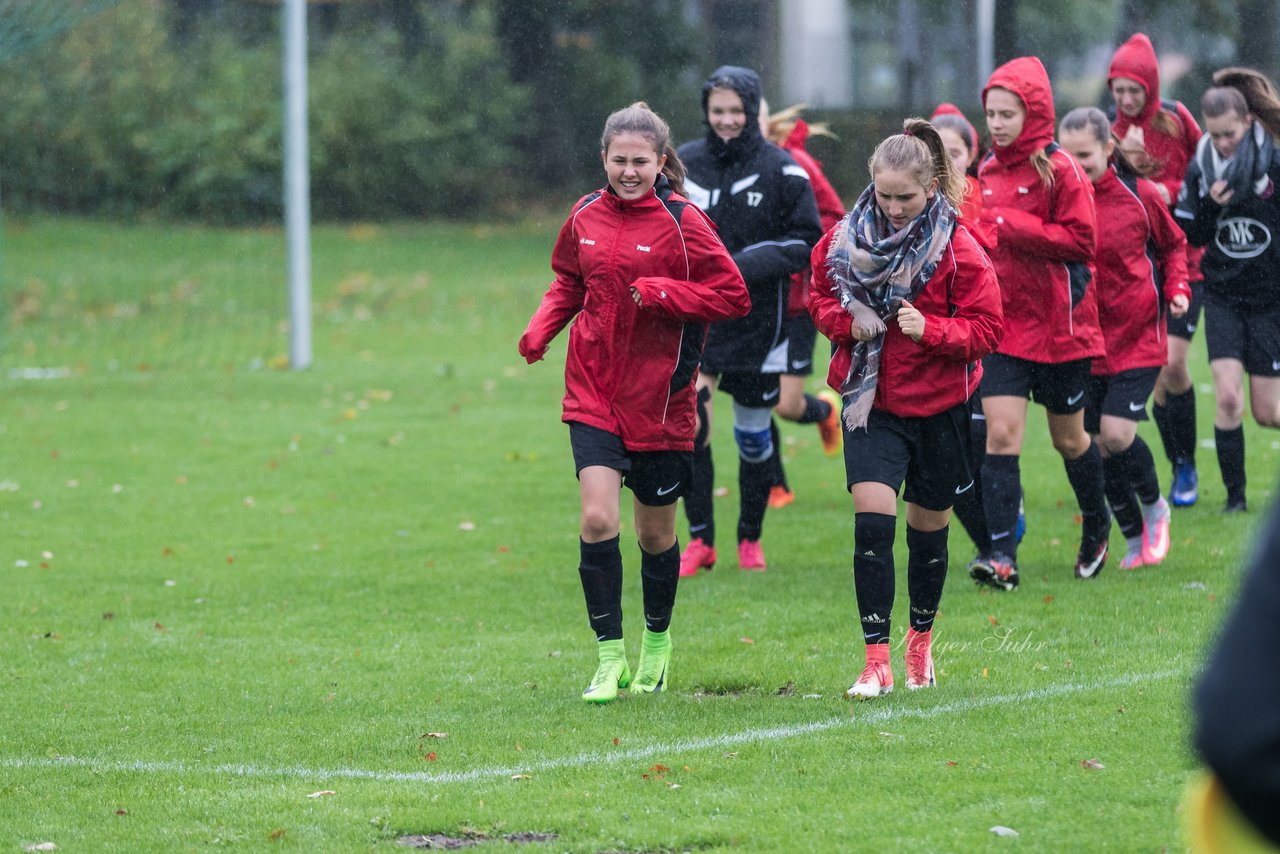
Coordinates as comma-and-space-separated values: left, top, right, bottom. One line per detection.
1174, 68, 1280, 512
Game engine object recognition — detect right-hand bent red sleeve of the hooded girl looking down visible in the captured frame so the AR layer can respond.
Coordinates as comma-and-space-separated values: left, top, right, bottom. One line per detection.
982, 155, 1097, 264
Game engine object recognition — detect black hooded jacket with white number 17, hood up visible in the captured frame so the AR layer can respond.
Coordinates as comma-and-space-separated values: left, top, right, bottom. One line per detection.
678, 65, 822, 374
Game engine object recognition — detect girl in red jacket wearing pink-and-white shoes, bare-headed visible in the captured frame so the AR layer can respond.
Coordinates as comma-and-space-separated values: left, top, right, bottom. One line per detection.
1059, 106, 1190, 570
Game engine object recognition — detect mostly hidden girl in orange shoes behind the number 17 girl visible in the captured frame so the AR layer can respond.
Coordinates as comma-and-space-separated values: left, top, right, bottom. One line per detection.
760, 100, 845, 507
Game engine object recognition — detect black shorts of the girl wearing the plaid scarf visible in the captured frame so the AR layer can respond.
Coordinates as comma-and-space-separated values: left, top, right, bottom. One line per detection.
845, 403, 973, 510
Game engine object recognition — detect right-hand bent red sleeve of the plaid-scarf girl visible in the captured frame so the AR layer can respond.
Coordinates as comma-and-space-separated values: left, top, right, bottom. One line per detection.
920, 225, 1005, 362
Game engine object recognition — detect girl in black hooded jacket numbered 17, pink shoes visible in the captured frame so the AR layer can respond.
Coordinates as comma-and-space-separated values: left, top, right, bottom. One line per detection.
678, 65, 822, 576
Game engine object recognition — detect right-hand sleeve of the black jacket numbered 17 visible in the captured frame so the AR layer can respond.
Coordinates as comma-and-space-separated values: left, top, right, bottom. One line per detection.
733, 155, 822, 286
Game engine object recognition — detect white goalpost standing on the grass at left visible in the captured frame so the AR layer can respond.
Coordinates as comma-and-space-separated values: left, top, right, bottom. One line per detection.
283, 0, 311, 370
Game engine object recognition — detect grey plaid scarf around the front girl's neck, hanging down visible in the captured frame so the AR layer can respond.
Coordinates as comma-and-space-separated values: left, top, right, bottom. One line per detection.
827, 183, 957, 430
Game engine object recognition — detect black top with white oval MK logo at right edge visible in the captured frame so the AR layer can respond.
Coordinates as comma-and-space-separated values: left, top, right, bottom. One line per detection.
1174, 150, 1280, 307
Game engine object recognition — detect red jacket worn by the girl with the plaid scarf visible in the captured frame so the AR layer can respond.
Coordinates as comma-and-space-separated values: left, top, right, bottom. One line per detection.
809, 225, 1004, 417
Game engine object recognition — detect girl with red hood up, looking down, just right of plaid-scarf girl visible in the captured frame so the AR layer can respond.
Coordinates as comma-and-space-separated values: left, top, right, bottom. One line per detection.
969, 56, 1111, 590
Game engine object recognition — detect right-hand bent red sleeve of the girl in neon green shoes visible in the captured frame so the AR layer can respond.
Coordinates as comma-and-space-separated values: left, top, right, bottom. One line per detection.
631, 205, 751, 323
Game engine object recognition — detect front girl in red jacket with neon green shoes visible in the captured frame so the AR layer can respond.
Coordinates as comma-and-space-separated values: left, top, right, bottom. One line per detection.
520, 101, 750, 703
